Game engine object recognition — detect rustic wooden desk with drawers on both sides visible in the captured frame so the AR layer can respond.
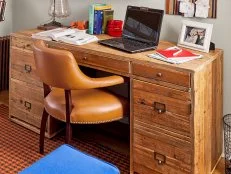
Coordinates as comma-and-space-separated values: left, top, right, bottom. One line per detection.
10, 30, 223, 174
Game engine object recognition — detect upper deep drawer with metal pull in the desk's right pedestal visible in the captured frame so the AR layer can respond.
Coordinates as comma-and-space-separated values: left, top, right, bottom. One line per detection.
133, 80, 191, 137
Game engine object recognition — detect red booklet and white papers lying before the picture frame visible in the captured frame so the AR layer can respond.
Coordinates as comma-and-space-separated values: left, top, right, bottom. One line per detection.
148, 46, 202, 64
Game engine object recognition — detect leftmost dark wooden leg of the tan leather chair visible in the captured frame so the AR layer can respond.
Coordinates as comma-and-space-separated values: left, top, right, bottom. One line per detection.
39, 108, 48, 154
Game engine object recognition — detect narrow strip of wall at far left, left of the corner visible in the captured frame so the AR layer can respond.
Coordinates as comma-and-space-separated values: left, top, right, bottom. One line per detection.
0, 0, 13, 36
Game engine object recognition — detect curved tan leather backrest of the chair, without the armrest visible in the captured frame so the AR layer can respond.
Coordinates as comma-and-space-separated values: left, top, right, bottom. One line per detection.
33, 40, 94, 90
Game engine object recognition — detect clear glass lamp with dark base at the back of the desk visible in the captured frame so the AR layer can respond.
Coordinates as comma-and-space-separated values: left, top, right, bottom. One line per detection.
38, 0, 71, 30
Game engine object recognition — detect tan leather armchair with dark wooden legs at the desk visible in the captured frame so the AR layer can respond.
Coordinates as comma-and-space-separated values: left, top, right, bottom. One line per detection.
33, 40, 128, 153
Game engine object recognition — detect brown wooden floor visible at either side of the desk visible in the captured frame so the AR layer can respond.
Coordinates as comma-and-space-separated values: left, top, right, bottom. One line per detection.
0, 91, 225, 174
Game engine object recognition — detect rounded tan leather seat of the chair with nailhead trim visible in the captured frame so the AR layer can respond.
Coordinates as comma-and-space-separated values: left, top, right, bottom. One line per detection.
44, 88, 128, 124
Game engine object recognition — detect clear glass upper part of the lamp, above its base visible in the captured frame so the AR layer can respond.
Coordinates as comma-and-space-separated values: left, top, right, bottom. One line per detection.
48, 0, 71, 18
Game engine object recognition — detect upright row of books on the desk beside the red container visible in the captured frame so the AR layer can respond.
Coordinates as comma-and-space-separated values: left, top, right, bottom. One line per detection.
88, 4, 114, 34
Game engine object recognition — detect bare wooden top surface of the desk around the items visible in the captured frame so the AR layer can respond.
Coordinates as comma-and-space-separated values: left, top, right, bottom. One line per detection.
11, 29, 223, 72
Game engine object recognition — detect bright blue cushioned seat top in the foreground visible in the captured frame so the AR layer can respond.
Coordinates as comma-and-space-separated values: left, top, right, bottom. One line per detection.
20, 144, 120, 174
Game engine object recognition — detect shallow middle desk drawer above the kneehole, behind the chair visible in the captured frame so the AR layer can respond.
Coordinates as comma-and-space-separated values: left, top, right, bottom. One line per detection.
74, 52, 130, 74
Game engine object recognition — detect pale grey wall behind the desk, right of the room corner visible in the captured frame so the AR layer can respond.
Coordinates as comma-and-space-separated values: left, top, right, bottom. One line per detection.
13, 0, 231, 114
